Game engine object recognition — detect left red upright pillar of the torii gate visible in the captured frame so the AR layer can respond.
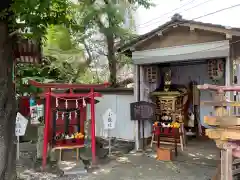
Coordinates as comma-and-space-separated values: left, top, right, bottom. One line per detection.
42, 90, 51, 169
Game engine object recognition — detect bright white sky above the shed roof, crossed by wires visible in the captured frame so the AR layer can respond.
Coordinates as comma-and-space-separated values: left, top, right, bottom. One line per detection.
136, 0, 240, 34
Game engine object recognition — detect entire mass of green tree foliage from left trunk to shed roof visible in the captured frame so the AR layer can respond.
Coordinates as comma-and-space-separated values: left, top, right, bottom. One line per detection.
12, 0, 152, 93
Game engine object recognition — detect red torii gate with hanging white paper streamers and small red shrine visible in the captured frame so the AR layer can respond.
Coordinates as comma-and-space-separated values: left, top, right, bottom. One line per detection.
29, 80, 109, 168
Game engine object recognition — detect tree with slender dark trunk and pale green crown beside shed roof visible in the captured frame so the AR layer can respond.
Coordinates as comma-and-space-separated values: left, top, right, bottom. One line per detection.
70, 0, 152, 86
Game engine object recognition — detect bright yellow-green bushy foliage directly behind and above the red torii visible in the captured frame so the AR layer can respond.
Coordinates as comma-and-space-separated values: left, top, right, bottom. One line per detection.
17, 21, 103, 94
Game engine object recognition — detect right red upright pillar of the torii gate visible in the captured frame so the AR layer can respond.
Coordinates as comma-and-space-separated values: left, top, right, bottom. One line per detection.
91, 88, 96, 165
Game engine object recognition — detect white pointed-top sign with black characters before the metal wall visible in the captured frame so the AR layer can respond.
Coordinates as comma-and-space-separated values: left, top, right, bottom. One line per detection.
103, 109, 116, 130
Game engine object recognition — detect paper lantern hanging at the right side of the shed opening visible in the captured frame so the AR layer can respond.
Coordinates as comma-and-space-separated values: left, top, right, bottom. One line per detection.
208, 59, 224, 81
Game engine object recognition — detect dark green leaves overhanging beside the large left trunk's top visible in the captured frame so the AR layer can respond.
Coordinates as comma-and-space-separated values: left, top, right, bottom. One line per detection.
11, 0, 71, 38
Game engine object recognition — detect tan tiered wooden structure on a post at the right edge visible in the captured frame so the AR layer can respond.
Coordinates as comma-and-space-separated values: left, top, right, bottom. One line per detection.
198, 84, 240, 180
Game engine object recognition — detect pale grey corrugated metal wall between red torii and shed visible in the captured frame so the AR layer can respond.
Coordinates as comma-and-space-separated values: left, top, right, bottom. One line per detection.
87, 94, 134, 140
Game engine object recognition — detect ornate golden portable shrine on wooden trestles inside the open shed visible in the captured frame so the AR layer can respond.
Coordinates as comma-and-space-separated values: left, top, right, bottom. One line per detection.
151, 70, 186, 150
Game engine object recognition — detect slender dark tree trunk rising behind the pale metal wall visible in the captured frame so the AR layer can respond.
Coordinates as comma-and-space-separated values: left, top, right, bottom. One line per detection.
106, 34, 117, 87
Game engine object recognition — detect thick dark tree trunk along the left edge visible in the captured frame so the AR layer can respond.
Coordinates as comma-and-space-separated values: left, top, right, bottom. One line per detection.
0, 21, 16, 180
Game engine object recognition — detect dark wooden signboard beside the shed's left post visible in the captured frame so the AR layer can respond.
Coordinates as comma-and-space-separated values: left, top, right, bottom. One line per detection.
130, 101, 156, 121
